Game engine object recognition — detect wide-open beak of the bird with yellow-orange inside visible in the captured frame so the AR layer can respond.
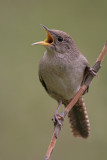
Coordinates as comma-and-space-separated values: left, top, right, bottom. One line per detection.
32, 24, 54, 46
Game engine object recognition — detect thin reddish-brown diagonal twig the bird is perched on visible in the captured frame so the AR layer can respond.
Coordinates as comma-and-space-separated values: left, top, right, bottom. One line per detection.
44, 41, 107, 160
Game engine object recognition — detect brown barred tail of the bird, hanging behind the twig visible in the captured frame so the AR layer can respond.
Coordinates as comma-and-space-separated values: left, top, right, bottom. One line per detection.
65, 97, 90, 138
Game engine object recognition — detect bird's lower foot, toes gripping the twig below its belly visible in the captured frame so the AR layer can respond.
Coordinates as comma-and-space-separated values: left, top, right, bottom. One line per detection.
52, 112, 64, 127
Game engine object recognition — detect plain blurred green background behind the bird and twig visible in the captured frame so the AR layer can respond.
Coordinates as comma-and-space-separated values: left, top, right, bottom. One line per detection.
0, 0, 107, 160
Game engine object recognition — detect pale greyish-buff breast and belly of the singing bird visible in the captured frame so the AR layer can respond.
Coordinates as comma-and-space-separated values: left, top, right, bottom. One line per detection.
39, 54, 86, 100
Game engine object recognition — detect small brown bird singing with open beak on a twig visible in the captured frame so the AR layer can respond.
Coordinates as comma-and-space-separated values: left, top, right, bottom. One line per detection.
32, 25, 90, 138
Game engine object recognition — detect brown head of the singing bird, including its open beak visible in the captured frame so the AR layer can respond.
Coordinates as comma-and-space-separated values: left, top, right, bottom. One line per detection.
32, 25, 76, 54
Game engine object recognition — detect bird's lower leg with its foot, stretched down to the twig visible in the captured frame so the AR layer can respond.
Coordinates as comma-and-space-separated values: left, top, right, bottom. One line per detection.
52, 101, 64, 126
